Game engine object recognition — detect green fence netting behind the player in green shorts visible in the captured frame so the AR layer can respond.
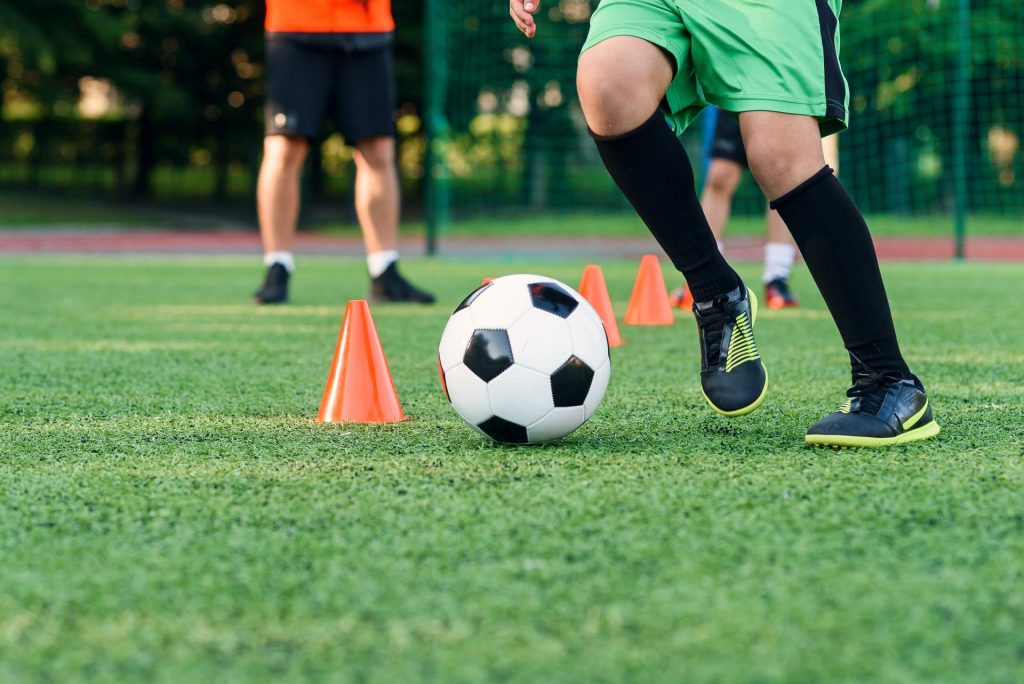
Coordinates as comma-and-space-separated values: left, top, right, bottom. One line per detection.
426, 0, 1024, 252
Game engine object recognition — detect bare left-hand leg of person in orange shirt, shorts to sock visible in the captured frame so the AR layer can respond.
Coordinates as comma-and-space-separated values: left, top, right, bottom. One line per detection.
256, 135, 309, 253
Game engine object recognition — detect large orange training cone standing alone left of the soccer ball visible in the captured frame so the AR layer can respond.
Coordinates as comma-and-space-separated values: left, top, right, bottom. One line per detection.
316, 299, 406, 423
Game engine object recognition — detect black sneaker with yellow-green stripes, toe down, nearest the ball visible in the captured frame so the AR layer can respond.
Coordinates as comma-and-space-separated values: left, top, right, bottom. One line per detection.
693, 284, 768, 416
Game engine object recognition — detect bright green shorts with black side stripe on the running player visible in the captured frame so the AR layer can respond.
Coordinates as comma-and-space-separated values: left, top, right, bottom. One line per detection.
583, 0, 849, 135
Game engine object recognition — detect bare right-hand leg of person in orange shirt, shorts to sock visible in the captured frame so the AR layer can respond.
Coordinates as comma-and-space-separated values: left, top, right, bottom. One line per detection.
355, 136, 400, 254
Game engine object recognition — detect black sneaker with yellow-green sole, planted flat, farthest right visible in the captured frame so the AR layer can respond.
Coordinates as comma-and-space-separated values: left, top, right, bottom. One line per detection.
804, 371, 939, 446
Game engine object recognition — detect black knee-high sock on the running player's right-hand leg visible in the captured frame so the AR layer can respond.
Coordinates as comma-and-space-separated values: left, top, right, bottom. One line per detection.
771, 166, 910, 377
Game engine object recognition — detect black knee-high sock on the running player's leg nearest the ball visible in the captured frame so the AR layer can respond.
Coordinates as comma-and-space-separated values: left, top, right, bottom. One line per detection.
591, 112, 740, 302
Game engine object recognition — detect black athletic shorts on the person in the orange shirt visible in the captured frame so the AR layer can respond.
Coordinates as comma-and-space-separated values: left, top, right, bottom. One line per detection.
264, 34, 395, 143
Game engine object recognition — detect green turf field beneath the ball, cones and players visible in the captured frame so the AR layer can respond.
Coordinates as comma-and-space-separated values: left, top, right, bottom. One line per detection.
0, 257, 1024, 682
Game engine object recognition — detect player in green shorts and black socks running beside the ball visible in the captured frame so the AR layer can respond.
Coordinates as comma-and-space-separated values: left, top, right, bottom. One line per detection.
509, 0, 939, 446
